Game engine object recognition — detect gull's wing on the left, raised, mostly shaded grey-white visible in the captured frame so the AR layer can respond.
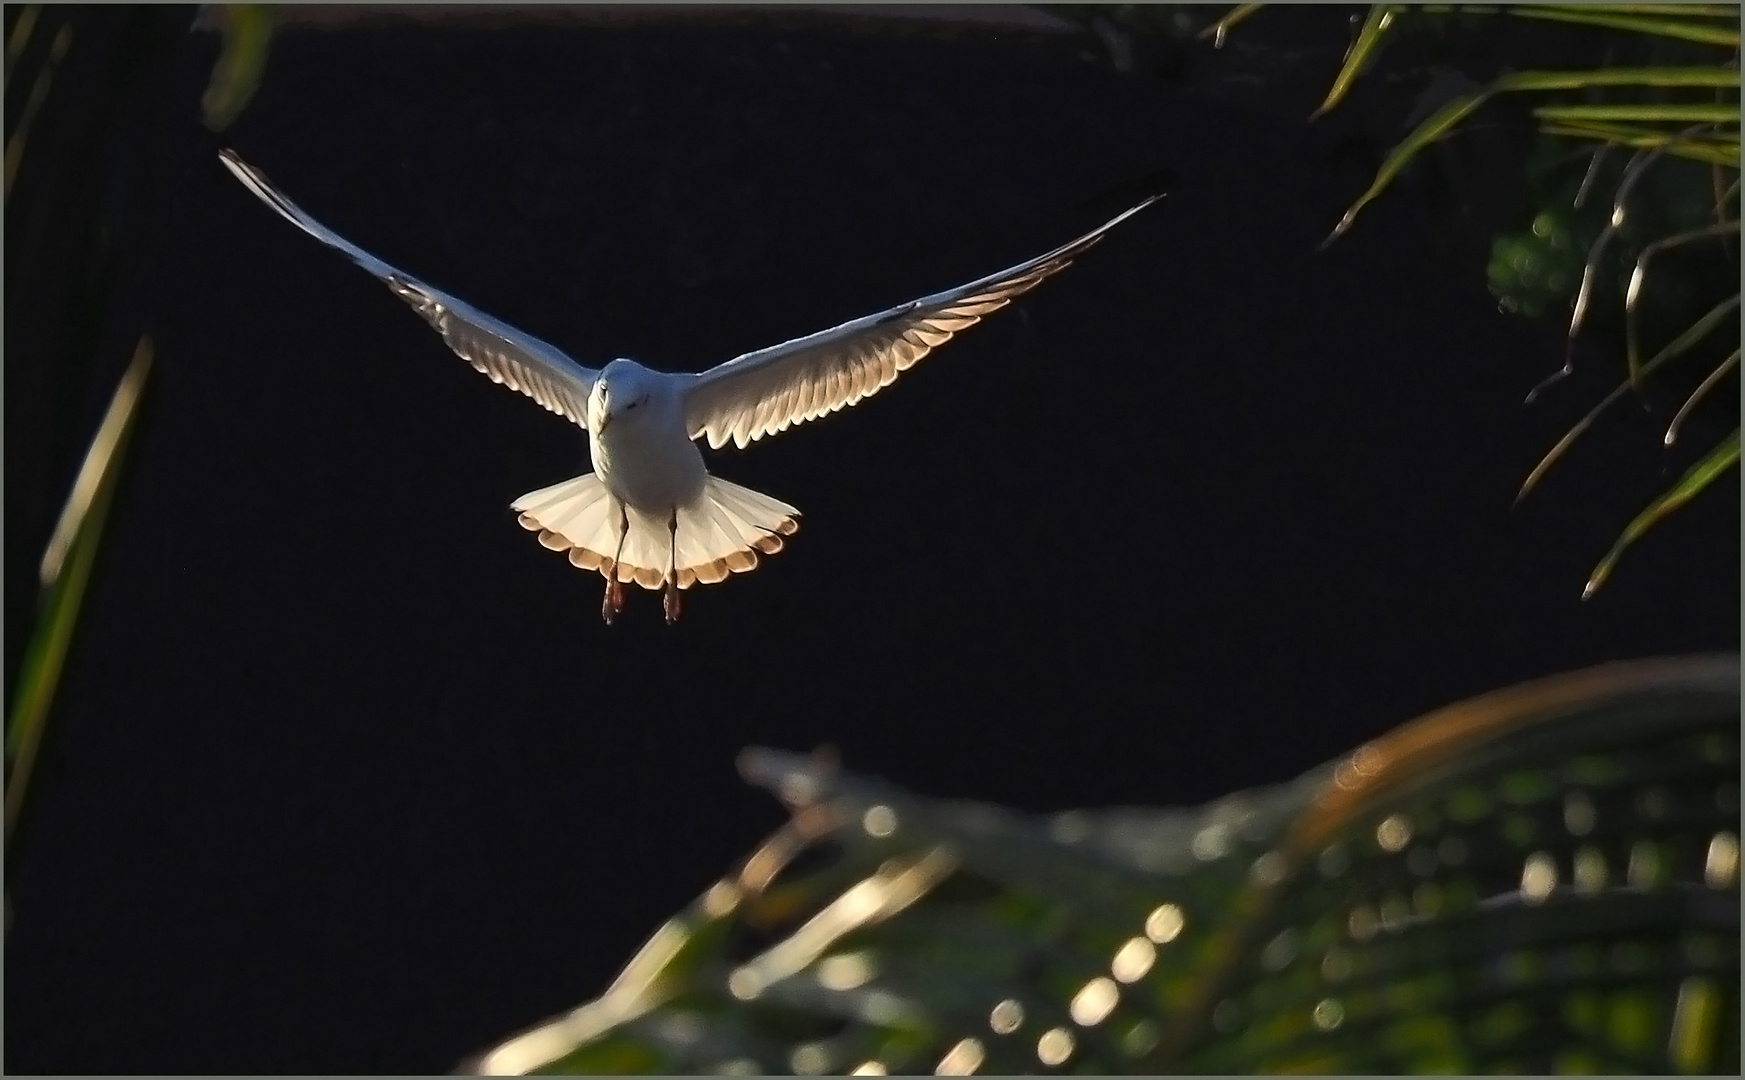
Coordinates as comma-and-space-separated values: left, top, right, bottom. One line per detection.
218, 150, 599, 427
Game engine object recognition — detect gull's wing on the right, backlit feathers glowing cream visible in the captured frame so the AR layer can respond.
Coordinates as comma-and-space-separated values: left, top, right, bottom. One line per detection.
684, 195, 1162, 448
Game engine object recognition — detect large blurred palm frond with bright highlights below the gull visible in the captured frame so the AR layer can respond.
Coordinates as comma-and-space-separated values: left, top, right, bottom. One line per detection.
468, 658, 1740, 1075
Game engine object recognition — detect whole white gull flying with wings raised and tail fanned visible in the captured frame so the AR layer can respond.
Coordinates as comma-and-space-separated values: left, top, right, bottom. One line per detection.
220, 148, 1162, 625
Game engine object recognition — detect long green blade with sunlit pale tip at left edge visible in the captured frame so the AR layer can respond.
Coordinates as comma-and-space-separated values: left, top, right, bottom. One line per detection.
5, 337, 152, 841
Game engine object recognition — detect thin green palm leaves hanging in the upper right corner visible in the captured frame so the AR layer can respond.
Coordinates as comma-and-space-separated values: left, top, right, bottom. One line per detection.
1235, 3, 1740, 598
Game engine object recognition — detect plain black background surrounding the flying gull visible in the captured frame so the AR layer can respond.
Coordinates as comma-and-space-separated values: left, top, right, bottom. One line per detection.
5, 4, 1740, 1073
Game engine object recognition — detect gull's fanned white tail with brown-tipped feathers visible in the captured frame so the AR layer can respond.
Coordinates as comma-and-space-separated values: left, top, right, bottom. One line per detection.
515, 473, 799, 588
